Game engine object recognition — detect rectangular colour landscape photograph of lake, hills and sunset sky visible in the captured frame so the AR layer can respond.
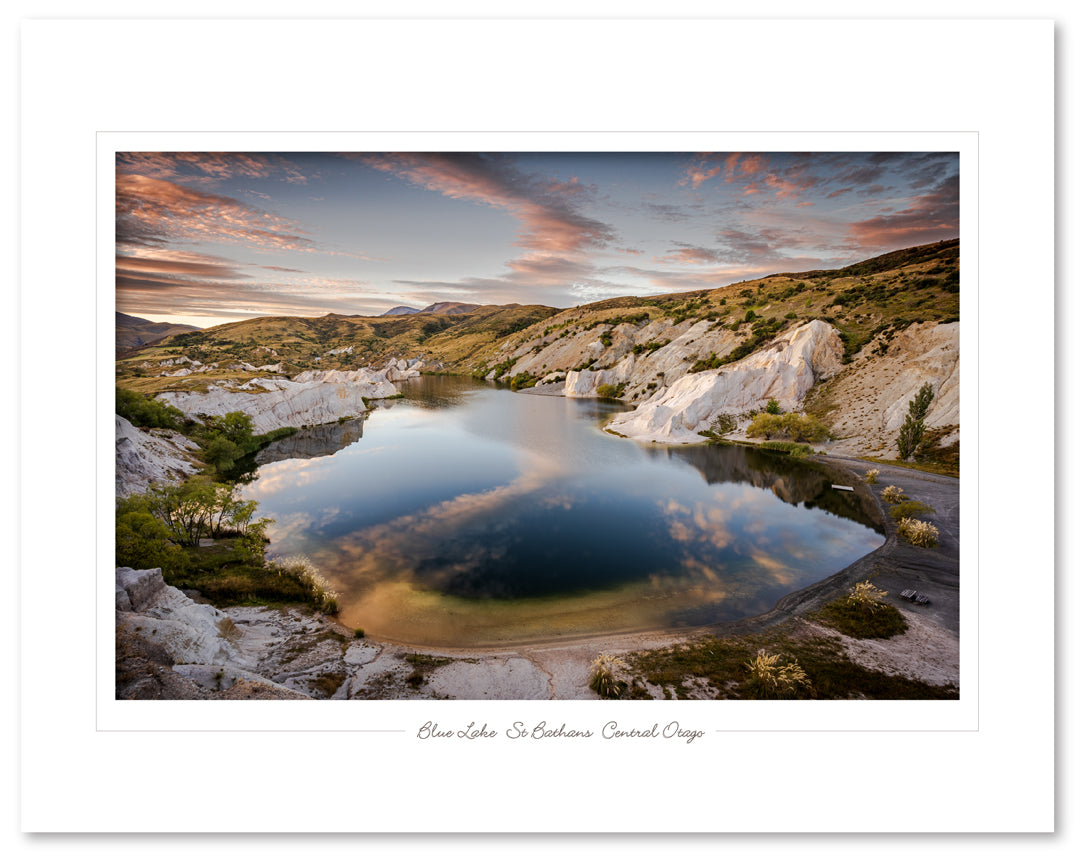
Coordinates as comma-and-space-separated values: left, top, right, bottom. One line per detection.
114, 151, 961, 700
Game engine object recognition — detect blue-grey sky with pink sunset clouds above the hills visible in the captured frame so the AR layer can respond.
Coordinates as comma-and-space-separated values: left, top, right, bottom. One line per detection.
116, 152, 960, 327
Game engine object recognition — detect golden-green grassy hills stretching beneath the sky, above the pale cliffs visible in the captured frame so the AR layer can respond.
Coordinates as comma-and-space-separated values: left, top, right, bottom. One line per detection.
117, 240, 960, 392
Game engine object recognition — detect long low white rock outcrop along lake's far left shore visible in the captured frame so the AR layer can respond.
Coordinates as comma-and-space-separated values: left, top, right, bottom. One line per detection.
159, 368, 397, 433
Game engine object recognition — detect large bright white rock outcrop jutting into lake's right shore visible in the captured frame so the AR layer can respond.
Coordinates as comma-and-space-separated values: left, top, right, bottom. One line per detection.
608, 320, 843, 443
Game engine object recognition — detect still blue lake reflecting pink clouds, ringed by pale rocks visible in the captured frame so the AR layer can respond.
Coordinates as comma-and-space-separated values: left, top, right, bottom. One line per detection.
244, 376, 885, 647
